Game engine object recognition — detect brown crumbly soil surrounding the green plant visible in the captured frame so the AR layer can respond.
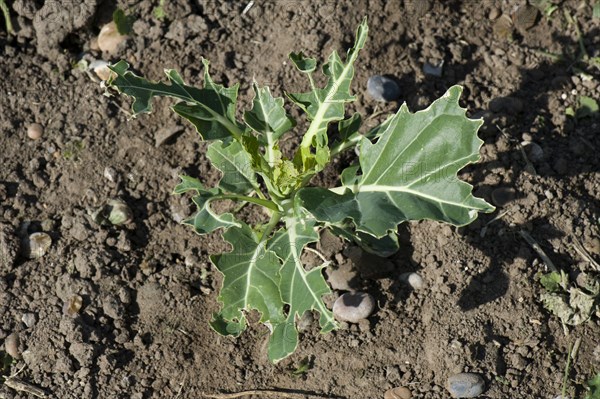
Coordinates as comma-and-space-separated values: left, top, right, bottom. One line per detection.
0, 0, 600, 399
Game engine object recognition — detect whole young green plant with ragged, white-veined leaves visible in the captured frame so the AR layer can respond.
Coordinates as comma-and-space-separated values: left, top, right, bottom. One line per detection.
108, 19, 494, 362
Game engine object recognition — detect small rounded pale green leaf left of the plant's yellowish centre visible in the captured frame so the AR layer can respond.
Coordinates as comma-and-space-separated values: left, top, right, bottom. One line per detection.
206, 141, 260, 194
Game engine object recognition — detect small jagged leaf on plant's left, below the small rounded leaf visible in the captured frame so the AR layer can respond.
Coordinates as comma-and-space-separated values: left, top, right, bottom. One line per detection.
174, 176, 241, 234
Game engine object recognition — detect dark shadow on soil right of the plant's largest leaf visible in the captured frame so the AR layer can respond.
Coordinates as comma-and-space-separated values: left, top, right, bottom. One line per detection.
458, 30, 600, 310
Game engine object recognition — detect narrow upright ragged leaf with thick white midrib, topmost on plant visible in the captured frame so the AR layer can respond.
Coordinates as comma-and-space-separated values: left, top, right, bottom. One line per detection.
288, 19, 368, 171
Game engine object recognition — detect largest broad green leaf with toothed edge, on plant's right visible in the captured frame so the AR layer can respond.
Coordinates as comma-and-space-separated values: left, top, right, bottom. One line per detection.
297, 86, 494, 241
